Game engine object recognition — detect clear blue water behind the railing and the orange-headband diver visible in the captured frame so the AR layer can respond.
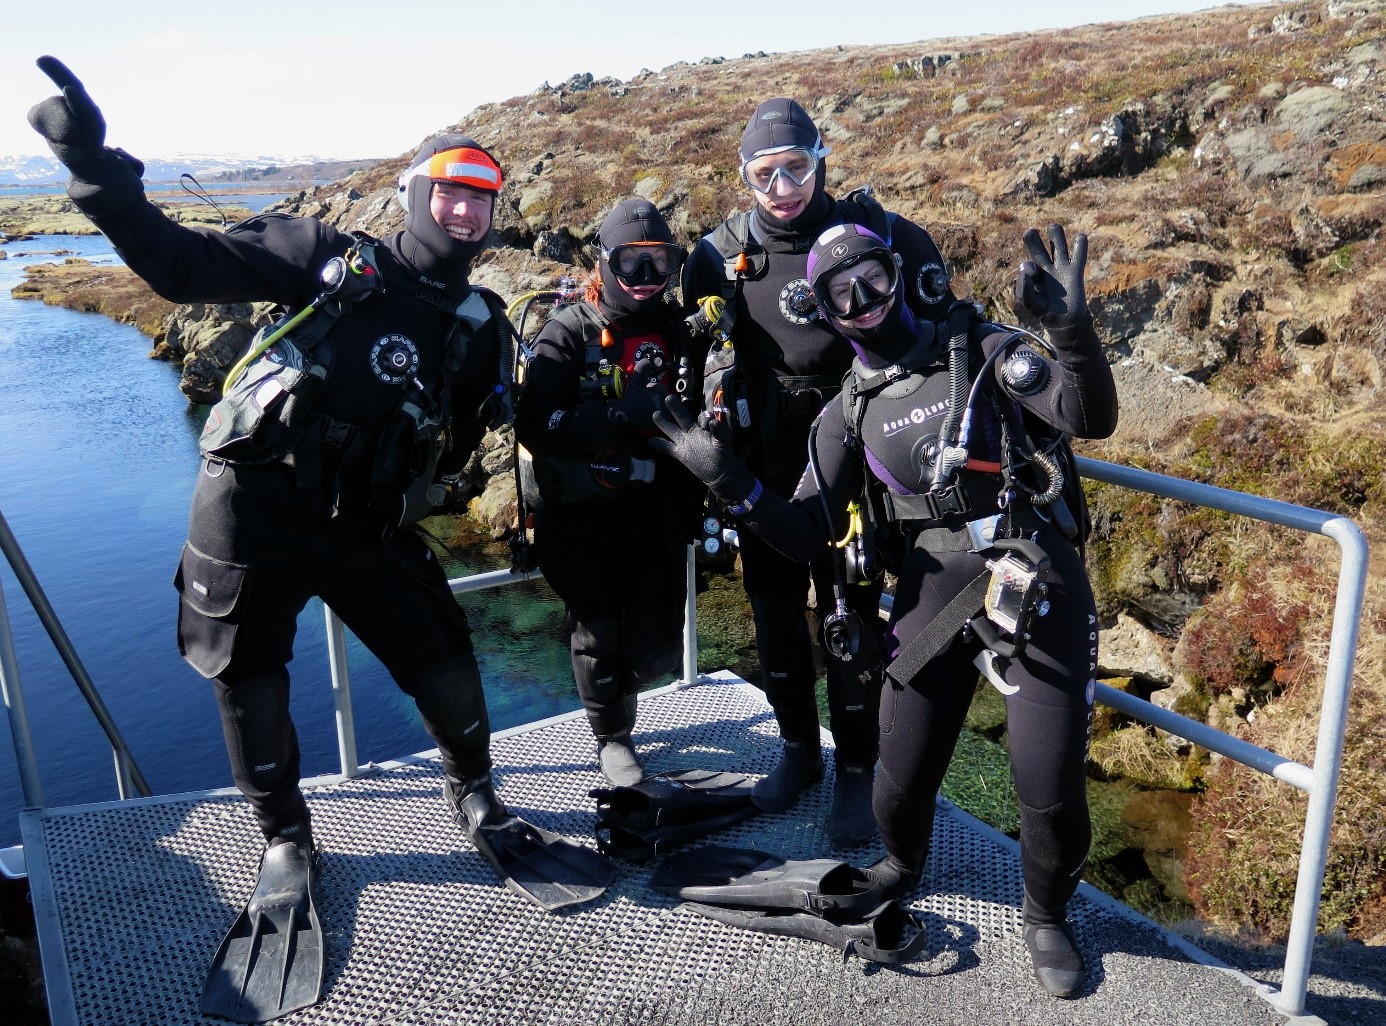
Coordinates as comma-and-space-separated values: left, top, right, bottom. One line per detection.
0, 236, 578, 846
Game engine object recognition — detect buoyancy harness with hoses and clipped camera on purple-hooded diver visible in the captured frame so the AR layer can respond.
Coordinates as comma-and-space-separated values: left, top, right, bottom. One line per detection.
809, 302, 1087, 686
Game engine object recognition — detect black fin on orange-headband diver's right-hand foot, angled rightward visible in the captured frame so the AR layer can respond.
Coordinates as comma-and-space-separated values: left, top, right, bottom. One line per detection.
457, 782, 615, 912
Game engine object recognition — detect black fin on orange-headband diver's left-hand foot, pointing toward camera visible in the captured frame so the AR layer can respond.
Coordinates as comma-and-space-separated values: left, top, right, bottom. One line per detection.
202, 842, 326, 1022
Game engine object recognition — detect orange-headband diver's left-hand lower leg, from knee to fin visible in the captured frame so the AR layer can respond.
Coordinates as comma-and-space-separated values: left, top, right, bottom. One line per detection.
212, 672, 308, 840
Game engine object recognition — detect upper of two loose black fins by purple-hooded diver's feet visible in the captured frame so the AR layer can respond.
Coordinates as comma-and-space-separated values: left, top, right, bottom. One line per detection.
650, 844, 884, 918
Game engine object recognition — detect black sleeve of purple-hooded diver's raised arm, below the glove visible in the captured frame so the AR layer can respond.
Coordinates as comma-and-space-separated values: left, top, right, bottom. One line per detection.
981, 315, 1117, 438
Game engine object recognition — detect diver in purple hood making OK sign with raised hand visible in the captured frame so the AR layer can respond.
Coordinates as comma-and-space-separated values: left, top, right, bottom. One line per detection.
653, 225, 1117, 997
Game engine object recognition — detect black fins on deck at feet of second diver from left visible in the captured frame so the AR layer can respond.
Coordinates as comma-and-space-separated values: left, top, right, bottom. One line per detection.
589, 770, 757, 862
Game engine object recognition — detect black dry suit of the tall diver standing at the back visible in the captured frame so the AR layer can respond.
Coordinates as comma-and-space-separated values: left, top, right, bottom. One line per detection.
683, 192, 952, 767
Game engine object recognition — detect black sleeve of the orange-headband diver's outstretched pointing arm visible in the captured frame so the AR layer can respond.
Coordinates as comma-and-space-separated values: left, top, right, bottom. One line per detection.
73, 183, 329, 306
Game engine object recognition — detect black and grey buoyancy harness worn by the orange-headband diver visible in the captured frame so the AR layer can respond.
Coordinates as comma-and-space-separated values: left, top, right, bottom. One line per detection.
200, 232, 511, 530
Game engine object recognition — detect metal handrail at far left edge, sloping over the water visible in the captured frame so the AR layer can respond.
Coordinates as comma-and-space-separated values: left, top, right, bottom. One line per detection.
0, 514, 151, 808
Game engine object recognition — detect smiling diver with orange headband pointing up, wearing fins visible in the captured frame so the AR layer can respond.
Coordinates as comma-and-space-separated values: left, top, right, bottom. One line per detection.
29, 57, 610, 1022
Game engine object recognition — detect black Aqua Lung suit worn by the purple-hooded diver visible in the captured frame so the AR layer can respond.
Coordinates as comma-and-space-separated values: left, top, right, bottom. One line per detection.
742, 293, 1116, 921
